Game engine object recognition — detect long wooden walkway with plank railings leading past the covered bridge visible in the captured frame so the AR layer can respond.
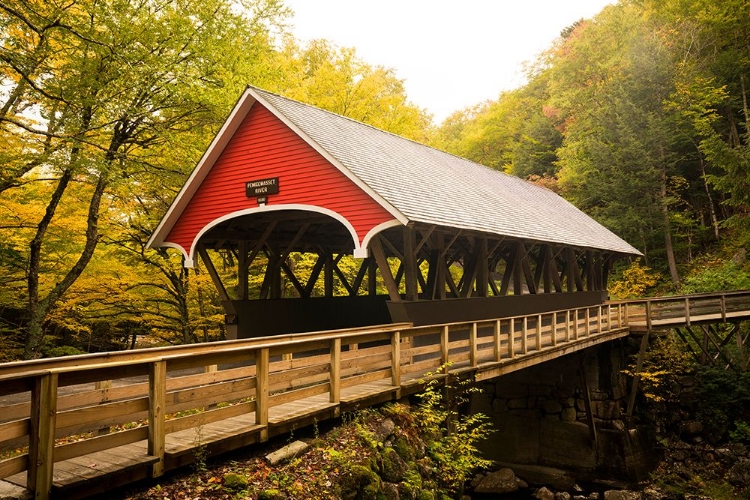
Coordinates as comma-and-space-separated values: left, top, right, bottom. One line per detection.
0, 292, 750, 498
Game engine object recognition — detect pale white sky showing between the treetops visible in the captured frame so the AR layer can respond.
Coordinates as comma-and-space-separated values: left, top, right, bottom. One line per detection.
285, 0, 615, 124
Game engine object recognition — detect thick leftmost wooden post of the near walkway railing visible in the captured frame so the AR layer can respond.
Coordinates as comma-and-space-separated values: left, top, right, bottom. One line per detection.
26, 373, 57, 500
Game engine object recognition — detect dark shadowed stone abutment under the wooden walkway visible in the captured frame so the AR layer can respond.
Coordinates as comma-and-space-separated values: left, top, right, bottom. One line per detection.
471, 341, 658, 481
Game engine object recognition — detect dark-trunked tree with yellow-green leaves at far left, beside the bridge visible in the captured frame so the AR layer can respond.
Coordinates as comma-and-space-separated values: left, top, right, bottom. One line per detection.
0, 0, 284, 358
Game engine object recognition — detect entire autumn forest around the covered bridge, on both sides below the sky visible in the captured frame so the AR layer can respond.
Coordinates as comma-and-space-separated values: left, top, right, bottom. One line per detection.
0, 0, 750, 360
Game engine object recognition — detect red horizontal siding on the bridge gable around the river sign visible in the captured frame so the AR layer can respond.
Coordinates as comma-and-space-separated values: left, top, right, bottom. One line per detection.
165, 103, 394, 253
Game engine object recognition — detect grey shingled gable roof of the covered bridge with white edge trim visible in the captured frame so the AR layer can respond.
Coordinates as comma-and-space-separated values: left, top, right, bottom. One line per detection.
149, 87, 640, 255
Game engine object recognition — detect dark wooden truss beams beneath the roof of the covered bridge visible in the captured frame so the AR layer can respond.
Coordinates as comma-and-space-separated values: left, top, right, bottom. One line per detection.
198, 215, 613, 302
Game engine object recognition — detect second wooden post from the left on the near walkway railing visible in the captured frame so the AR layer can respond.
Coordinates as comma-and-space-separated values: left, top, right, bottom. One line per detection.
148, 361, 167, 477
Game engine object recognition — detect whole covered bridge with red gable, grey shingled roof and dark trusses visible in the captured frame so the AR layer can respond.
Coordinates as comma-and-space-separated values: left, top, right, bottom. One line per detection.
149, 87, 639, 338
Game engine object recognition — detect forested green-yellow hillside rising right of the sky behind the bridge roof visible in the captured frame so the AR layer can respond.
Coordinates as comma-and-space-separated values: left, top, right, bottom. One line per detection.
433, 0, 750, 292
